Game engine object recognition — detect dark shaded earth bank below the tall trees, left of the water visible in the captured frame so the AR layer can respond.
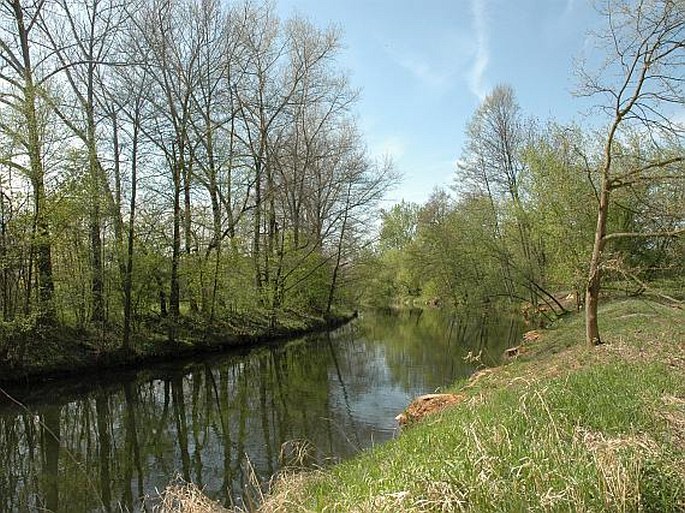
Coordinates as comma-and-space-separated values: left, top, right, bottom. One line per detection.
0, 312, 357, 384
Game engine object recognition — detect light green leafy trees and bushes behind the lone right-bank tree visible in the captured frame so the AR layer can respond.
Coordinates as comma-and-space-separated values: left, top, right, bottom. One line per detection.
371, 113, 685, 313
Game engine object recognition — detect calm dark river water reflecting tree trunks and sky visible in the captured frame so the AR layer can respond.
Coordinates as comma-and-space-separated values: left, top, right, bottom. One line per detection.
0, 310, 522, 513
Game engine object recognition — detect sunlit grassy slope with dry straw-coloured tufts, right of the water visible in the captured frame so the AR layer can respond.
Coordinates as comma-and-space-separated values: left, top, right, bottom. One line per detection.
219, 299, 685, 513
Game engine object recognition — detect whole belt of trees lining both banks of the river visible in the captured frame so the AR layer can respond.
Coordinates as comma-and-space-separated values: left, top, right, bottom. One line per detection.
0, 0, 685, 370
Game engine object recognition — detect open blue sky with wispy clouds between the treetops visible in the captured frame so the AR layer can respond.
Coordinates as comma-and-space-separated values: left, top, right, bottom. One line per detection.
277, 0, 601, 203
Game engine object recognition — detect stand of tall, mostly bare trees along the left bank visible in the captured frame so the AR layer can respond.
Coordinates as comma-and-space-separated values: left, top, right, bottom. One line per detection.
0, 0, 396, 358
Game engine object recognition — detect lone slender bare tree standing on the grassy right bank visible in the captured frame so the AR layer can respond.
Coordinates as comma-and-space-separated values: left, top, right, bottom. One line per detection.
579, 0, 685, 346
